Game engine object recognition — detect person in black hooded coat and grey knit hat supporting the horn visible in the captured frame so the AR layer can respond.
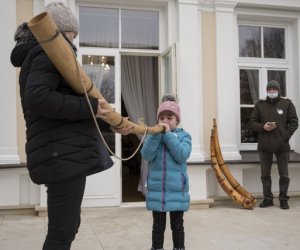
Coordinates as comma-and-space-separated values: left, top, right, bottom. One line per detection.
11, 2, 124, 250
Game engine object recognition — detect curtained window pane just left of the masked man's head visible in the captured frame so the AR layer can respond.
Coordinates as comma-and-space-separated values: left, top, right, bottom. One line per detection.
240, 69, 259, 104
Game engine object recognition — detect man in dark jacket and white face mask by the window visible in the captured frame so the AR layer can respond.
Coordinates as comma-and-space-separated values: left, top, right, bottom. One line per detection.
250, 80, 298, 209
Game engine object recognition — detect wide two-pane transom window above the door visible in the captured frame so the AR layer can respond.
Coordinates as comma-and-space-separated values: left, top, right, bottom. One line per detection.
79, 6, 159, 50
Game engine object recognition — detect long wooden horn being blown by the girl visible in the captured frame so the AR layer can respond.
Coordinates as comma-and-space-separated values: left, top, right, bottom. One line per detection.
28, 12, 164, 134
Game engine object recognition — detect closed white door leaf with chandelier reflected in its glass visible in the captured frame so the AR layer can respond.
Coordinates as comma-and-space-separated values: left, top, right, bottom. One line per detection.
78, 49, 121, 207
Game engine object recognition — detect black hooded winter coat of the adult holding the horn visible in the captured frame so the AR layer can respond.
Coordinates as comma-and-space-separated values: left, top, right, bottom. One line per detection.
11, 23, 113, 184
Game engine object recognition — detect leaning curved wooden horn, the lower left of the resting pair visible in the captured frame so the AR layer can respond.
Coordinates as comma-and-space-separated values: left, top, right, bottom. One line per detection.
210, 130, 253, 209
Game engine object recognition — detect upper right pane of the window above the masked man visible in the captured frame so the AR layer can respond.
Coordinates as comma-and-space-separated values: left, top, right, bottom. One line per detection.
263, 27, 285, 58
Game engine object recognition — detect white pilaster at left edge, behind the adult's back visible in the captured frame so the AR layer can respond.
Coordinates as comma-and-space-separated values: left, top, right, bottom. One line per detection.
0, 0, 20, 164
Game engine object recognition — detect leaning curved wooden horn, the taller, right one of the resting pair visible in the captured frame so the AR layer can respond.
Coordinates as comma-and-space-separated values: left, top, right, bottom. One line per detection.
213, 119, 256, 205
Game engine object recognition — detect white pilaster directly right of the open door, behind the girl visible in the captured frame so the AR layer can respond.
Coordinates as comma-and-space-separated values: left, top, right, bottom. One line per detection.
178, 0, 205, 162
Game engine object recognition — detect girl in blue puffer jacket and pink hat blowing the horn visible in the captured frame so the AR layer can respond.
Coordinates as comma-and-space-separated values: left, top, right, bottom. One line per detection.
141, 100, 191, 250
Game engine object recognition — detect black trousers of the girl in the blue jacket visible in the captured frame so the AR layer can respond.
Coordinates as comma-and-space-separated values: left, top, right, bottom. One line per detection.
152, 211, 184, 249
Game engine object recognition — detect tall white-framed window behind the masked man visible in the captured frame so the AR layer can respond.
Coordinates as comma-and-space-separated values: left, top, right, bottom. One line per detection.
238, 24, 288, 145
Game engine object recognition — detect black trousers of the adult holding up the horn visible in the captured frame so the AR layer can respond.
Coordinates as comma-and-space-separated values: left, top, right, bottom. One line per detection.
43, 175, 86, 250
